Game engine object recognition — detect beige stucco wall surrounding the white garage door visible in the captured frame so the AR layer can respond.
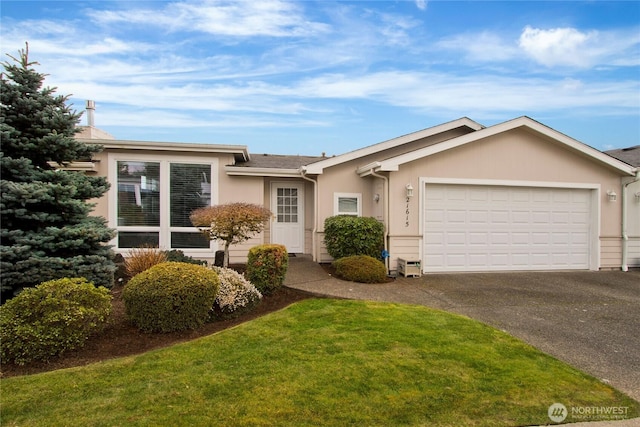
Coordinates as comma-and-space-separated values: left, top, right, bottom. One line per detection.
390, 130, 621, 268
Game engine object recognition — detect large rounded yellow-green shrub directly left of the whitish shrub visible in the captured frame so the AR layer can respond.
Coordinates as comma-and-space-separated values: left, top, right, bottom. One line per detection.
122, 262, 220, 332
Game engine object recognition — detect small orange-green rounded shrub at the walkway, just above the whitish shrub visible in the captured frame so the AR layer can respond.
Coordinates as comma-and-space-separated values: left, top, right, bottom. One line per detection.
246, 244, 289, 295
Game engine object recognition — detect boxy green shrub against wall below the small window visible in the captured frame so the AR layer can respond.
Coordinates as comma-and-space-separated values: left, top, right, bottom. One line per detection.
324, 215, 384, 259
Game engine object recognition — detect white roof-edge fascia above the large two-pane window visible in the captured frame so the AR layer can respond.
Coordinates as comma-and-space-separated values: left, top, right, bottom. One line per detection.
79, 139, 250, 161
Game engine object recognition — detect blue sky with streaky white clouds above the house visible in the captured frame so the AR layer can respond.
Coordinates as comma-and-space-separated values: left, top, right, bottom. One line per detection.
0, 0, 640, 155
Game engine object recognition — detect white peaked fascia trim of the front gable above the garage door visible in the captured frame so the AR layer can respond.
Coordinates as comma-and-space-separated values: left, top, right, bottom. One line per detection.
357, 116, 635, 176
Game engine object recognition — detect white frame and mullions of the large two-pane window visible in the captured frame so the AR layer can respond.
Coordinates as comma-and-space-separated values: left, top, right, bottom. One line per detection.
107, 153, 219, 255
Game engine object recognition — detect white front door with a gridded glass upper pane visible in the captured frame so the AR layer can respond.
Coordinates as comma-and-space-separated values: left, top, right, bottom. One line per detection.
271, 182, 304, 253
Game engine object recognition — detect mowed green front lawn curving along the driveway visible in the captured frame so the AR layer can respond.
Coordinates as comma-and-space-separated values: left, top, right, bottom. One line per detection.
0, 299, 638, 426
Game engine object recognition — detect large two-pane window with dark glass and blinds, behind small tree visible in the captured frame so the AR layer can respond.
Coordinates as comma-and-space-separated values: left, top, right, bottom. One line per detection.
112, 158, 217, 251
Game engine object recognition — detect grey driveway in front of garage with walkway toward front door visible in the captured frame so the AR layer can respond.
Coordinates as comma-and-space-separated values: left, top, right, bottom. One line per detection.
284, 255, 640, 427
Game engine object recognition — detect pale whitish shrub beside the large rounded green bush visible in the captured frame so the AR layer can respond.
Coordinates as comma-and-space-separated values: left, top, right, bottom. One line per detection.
212, 266, 262, 319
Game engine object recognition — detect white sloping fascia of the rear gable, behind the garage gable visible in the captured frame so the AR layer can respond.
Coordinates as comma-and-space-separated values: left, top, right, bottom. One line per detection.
307, 117, 484, 175
